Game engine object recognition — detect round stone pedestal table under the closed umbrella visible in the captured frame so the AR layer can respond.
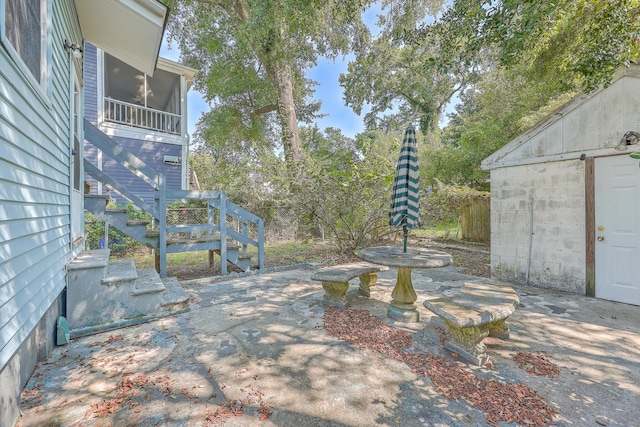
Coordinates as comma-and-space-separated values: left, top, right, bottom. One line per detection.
357, 246, 452, 323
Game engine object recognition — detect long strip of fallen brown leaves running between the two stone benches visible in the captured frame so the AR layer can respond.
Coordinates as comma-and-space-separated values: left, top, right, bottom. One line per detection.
324, 307, 556, 427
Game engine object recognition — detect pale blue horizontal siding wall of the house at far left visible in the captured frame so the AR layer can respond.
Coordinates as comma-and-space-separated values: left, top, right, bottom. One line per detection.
0, 0, 82, 426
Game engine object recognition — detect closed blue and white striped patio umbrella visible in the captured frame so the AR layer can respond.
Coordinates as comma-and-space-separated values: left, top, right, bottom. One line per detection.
389, 124, 420, 252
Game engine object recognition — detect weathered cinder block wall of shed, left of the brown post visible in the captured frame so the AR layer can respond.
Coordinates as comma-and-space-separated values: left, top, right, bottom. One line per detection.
491, 160, 586, 294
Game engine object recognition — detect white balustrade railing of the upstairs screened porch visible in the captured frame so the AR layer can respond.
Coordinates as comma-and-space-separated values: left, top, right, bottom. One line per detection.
104, 97, 182, 135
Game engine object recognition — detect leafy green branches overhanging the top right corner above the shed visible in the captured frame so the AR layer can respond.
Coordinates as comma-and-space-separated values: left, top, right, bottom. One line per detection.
412, 0, 640, 92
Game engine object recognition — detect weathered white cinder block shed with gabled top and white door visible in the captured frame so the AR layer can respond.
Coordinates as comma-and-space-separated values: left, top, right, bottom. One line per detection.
482, 65, 640, 305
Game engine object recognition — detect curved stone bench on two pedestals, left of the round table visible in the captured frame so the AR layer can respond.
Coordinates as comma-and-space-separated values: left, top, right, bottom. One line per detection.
311, 262, 389, 307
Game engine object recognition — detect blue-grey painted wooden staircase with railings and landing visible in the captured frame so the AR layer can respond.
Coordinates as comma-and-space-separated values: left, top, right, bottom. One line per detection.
84, 120, 264, 277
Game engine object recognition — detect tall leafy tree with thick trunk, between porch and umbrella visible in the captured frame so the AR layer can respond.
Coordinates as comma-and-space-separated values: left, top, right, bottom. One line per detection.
168, 0, 369, 181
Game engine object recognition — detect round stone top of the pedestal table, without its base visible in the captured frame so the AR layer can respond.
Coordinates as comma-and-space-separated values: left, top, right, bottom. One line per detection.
357, 246, 453, 268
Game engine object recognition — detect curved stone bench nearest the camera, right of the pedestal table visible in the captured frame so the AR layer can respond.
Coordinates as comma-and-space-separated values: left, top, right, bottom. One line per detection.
424, 283, 520, 366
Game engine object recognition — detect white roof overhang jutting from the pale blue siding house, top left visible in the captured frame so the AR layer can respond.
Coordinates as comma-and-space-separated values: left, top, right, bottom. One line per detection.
75, 0, 169, 76
